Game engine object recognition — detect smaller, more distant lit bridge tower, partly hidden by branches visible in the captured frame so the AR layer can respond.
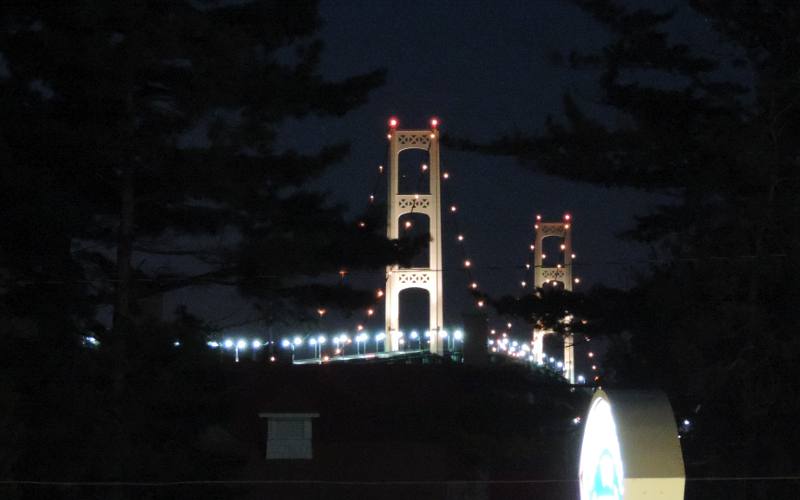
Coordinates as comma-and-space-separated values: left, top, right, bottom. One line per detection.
532, 214, 575, 384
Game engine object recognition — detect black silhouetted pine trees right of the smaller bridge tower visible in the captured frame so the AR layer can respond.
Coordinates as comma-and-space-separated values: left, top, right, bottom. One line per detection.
450, 0, 800, 490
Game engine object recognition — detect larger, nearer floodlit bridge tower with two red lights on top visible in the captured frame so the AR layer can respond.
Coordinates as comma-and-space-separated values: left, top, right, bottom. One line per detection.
385, 118, 444, 355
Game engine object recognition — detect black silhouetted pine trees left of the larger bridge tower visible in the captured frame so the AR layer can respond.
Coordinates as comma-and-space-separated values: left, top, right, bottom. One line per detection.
0, 0, 413, 498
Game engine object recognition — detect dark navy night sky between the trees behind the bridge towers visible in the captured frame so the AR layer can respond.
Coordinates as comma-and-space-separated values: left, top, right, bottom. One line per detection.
186, 0, 658, 336
